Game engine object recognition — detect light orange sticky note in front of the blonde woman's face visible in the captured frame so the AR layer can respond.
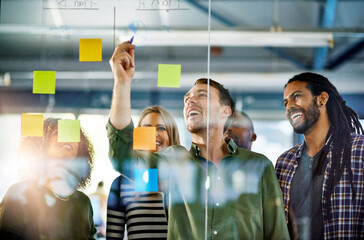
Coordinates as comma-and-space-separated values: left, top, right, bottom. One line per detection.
133, 127, 157, 150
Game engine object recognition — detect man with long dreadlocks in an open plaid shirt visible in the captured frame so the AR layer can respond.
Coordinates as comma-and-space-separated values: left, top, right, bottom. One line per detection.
276, 72, 364, 239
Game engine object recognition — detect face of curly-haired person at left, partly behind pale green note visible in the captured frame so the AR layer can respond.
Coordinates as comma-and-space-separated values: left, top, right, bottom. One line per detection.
48, 129, 80, 159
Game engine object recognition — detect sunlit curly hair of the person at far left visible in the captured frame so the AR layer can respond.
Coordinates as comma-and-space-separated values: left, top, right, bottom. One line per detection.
18, 118, 95, 188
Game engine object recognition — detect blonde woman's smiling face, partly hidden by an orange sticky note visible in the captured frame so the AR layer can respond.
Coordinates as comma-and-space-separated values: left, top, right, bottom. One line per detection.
140, 112, 170, 151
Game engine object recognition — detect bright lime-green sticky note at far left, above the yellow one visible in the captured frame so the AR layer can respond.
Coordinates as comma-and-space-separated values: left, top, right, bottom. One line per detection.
33, 71, 56, 94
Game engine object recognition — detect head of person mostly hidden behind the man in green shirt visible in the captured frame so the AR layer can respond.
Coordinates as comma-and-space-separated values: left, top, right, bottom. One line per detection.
224, 111, 257, 151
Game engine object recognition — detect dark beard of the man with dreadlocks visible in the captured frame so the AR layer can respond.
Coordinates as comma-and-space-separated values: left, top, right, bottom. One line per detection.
291, 97, 320, 134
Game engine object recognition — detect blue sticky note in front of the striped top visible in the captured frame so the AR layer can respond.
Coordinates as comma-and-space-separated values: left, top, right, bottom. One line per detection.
134, 168, 158, 192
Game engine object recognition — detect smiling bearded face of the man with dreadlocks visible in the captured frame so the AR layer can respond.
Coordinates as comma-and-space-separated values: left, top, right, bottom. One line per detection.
283, 81, 320, 134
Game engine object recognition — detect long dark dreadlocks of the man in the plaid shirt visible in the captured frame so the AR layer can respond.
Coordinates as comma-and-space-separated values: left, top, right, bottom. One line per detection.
285, 72, 363, 217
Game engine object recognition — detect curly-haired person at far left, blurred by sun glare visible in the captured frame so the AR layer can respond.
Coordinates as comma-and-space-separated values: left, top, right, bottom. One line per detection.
0, 118, 96, 239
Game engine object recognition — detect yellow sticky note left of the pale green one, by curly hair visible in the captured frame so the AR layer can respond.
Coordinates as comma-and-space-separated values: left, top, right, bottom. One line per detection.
21, 113, 44, 137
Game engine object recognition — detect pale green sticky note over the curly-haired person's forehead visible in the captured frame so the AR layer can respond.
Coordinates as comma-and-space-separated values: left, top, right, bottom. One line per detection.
58, 119, 81, 142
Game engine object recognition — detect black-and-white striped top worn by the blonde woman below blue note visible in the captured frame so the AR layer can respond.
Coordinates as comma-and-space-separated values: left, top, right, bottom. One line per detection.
106, 176, 168, 239
